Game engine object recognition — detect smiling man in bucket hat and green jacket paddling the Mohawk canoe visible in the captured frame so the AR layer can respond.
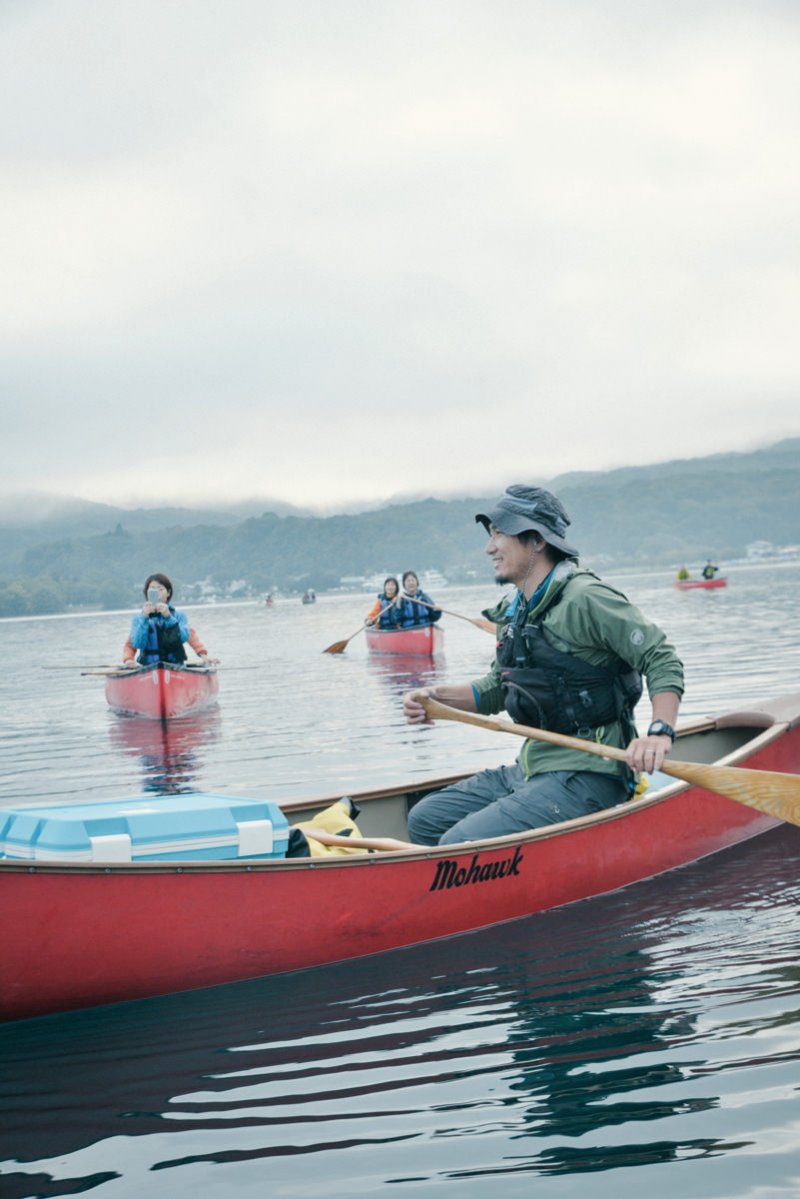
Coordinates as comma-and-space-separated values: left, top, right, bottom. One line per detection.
404, 483, 684, 845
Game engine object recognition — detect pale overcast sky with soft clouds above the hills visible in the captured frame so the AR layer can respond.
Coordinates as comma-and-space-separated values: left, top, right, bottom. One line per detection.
0, 0, 800, 507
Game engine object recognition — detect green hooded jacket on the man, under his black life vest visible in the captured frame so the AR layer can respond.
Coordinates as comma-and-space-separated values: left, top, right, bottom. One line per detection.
473, 560, 684, 778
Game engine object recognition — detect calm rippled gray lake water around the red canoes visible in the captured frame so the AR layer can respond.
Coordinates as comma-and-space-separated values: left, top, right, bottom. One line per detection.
0, 564, 800, 1199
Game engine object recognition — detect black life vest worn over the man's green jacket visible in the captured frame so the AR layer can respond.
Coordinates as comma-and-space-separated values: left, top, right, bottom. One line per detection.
498, 601, 642, 737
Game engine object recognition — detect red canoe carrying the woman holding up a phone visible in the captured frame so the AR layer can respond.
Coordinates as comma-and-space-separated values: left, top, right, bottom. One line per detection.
106, 663, 219, 721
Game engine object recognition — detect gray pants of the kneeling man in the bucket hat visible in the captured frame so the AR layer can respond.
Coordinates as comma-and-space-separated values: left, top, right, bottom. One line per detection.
408, 763, 628, 845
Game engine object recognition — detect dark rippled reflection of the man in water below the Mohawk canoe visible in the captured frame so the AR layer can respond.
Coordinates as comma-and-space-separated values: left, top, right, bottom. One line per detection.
509, 911, 718, 1175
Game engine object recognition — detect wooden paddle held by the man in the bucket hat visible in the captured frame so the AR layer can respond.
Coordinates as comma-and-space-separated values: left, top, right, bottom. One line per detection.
421, 697, 800, 825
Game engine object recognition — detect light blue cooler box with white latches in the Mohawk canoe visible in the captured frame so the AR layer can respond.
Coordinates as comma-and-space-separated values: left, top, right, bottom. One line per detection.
0, 795, 289, 862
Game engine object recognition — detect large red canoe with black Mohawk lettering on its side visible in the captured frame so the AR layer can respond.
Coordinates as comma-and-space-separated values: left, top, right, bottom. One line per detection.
0, 694, 800, 1019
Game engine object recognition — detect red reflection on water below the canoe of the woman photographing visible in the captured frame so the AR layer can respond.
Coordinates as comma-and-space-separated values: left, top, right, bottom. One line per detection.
109, 707, 221, 795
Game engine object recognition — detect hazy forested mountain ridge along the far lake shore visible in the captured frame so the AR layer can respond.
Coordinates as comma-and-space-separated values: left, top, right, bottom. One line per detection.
0, 438, 800, 615
